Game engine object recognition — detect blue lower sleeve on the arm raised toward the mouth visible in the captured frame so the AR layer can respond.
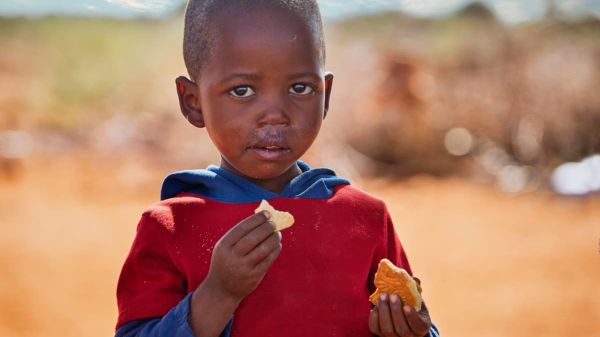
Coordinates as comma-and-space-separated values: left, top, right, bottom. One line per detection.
115, 293, 232, 337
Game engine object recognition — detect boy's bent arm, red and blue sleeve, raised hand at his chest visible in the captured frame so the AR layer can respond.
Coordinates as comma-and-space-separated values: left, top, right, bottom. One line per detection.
117, 212, 281, 337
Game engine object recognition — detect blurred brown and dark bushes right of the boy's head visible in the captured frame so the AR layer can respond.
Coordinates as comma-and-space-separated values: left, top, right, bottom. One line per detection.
346, 4, 600, 191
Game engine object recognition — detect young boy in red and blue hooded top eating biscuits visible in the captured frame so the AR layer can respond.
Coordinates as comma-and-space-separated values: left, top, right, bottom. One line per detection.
116, 0, 437, 337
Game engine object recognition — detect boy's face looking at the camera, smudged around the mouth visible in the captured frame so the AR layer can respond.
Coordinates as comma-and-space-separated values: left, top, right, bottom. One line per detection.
180, 4, 333, 189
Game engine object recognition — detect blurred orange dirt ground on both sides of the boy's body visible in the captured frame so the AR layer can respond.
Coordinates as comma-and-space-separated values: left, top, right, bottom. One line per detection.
0, 161, 600, 337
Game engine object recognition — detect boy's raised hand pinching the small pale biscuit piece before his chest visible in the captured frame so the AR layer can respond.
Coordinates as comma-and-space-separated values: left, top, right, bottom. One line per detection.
205, 211, 281, 301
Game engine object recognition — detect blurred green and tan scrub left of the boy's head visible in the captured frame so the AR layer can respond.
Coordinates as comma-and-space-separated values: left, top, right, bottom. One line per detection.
0, 14, 206, 169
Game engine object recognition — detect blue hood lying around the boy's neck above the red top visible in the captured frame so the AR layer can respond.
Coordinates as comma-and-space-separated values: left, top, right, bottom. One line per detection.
160, 161, 350, 203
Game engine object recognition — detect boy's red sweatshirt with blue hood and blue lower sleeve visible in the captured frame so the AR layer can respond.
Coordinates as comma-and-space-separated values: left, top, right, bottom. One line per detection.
116, 162, 437, 337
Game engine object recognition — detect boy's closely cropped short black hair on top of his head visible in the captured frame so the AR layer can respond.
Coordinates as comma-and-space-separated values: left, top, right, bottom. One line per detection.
183, 0, 325, 81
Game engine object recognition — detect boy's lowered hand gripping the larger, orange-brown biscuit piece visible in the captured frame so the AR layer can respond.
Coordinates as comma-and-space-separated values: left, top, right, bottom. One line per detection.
369, 279, 431, 337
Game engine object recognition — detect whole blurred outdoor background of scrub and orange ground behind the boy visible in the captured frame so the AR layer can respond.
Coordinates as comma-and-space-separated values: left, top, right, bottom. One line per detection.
0, 0, 600, 337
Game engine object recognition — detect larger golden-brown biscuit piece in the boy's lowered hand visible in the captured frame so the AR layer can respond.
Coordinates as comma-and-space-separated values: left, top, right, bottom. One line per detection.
369, 259, 423, 311
